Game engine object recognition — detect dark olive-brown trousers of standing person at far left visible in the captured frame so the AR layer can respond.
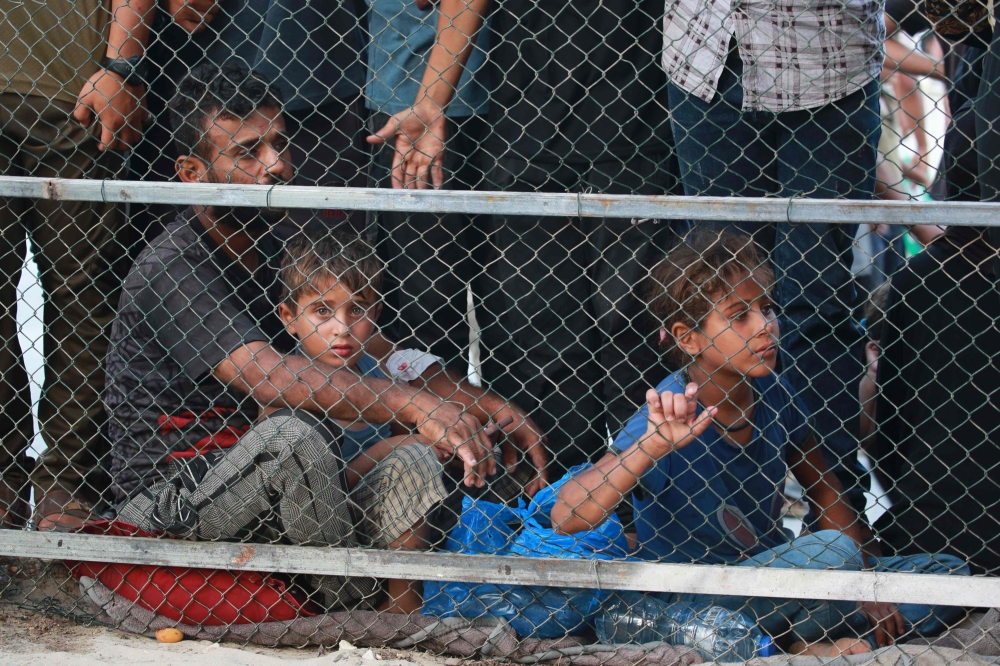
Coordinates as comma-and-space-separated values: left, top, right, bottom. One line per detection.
0, 93, 127, 500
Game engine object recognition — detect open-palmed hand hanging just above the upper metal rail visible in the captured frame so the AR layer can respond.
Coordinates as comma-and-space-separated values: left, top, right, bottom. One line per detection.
367, 106, 447, 190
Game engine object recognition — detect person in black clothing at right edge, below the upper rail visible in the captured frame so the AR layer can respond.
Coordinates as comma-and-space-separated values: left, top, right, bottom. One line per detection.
868, 227, 1000, 576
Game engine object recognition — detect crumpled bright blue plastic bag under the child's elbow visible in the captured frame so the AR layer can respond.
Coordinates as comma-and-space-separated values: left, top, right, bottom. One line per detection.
423, 465, 628, 638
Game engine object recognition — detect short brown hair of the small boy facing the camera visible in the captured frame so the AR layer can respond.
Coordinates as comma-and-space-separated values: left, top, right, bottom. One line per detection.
280, 231, 383, 311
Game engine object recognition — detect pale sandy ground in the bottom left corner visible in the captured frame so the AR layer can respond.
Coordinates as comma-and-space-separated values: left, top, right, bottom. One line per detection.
0, 558, 456, 666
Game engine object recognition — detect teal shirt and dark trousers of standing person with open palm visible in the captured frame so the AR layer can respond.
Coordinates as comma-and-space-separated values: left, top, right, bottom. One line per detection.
365, 0, 489, 375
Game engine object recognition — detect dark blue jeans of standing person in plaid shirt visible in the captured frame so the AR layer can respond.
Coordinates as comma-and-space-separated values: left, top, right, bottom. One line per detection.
668, 49, 881, 511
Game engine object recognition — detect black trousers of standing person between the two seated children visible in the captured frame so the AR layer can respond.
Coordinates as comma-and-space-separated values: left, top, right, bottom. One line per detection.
480, 155, 672, 478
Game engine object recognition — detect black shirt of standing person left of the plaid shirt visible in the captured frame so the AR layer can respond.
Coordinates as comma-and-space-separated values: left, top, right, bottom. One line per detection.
487, 0, 670, 164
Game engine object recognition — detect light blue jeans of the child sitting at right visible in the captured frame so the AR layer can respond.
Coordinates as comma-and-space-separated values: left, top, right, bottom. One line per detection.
669, 530, 969, 643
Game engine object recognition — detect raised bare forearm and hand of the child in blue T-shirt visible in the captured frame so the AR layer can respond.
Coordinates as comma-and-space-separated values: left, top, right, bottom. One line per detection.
551, 384, 717, 534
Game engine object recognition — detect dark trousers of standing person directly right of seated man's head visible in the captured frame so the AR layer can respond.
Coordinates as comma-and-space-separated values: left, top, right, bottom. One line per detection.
278, 97, 370, 238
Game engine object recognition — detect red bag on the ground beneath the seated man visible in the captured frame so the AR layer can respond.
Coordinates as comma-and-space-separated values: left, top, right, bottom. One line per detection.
66, 520, 317, 626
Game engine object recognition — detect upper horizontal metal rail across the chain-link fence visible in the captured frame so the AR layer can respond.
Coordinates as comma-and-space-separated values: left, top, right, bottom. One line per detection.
0, 176, 1000, 227
